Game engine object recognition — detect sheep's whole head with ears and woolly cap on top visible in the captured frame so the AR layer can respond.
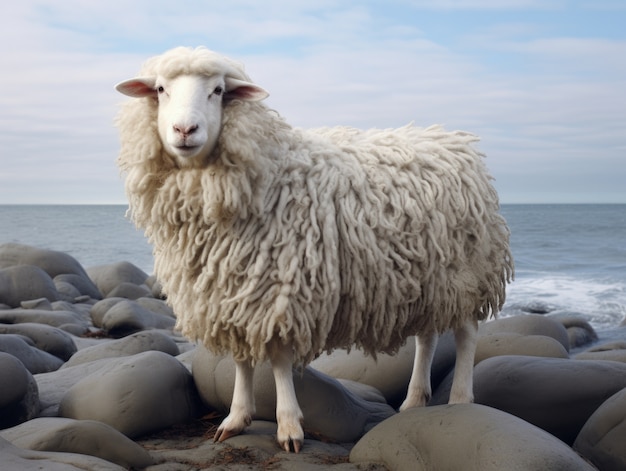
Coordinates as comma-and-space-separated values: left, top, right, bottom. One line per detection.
115, 48, 268, 167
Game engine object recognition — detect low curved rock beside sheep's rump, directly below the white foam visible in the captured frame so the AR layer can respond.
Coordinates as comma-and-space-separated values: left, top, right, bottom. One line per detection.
479, 314, 569, 352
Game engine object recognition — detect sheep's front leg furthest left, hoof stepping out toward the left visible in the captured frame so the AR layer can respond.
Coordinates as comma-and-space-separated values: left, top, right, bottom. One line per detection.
213, 361, 255, 442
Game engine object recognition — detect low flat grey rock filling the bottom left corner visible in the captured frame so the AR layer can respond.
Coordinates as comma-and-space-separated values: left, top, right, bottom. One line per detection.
0, 438, 125, 471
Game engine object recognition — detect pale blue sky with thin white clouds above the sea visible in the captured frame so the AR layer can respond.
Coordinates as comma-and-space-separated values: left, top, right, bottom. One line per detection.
0, 0, 626, 204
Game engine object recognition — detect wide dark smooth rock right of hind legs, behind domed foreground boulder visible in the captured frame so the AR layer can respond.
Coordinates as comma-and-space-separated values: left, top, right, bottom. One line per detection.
431, 356, 626, 445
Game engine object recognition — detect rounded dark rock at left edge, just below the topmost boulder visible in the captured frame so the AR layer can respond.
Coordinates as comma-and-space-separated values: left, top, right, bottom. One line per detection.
0, 265, 60, 307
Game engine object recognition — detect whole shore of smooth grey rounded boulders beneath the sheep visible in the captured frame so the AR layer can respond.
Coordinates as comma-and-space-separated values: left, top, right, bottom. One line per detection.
0, 244, 626, 471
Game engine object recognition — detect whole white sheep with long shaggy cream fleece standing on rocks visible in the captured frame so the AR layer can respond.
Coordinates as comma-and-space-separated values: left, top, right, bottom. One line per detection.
116, 47, 513, 452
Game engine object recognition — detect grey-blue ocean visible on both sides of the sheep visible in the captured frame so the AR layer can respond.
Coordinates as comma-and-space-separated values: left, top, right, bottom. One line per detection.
0, 205, 626, 330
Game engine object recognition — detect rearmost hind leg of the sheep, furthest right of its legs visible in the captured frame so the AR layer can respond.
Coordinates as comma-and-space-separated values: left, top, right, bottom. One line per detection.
448, 320, 478, 404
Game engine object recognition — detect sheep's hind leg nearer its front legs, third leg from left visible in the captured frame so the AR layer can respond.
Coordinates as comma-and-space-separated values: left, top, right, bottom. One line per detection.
400, 332, 439, 411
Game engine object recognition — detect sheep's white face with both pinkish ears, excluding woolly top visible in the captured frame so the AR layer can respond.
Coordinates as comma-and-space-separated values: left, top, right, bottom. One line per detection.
116, 74, 268, 167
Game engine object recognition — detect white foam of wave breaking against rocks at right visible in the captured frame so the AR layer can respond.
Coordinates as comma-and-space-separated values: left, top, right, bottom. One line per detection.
504, 274, 626, 328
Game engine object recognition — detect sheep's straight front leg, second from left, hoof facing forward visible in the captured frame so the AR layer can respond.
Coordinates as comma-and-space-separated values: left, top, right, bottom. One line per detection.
270, 345, 304, 453
